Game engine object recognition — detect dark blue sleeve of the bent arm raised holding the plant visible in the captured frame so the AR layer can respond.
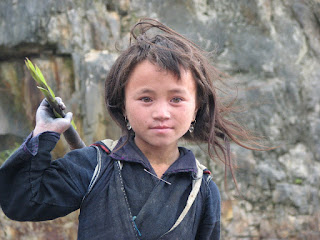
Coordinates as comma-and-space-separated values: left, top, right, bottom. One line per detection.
0, 132, 97, 221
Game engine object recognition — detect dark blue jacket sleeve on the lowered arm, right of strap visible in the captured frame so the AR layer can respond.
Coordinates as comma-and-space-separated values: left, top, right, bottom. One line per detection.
196, 177, 221, 240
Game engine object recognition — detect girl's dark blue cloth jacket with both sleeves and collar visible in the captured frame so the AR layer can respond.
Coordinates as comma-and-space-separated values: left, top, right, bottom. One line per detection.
0, 132, 220, 240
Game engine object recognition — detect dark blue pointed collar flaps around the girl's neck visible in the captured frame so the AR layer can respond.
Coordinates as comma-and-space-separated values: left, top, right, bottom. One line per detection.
110, 136, 197, 174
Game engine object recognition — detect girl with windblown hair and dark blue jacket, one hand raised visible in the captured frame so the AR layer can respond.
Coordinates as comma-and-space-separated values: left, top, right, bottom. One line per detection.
0, 19, 256, 240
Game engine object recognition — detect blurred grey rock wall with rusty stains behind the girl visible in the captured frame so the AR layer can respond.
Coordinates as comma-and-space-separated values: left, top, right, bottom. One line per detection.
0, 0, 320, 239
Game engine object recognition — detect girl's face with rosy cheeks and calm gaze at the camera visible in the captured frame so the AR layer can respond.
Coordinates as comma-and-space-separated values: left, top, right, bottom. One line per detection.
124, 60, 197, 152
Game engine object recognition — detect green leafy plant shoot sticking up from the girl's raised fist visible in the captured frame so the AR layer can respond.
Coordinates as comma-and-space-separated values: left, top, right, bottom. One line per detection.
25, 58, 76, 129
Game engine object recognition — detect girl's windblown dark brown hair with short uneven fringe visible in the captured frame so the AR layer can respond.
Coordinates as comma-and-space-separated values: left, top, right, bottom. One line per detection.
105, 18, 259, 188
